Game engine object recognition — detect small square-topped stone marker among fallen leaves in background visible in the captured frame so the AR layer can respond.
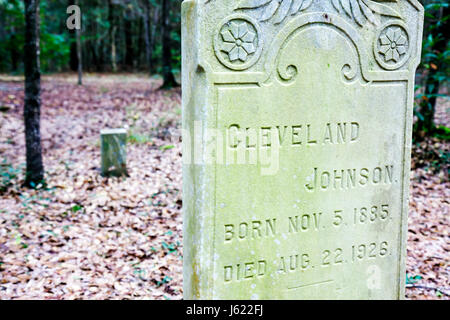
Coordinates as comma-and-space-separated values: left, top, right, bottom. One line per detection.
100, 129, 127, 176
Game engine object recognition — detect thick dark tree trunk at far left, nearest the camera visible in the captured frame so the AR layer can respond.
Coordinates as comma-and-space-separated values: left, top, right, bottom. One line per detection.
24, 0, 44, 186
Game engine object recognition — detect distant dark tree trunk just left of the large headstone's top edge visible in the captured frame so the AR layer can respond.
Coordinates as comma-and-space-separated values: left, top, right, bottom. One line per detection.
161, 0, 178, 89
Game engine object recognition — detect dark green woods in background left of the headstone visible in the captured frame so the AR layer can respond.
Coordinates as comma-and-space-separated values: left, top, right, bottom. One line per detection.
0, 0, 181, 74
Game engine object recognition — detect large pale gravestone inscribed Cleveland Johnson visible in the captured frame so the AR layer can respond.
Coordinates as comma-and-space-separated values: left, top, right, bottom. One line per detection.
182, 0, 423, 299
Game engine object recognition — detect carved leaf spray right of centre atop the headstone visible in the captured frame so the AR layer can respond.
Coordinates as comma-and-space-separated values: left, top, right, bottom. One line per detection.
331, 0, 401, 26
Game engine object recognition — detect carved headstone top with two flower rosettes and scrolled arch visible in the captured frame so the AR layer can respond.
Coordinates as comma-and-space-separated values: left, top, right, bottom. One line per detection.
207, 0, 421, 82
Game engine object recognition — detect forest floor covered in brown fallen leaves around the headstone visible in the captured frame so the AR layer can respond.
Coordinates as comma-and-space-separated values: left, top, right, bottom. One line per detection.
0, 74, 450, 299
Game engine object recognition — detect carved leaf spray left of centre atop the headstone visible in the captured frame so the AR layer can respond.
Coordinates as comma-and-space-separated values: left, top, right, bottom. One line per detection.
237, 0, 313, 24
